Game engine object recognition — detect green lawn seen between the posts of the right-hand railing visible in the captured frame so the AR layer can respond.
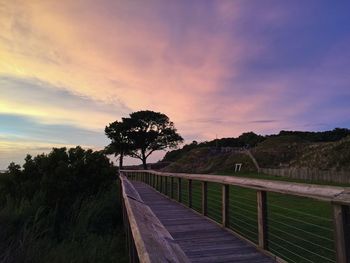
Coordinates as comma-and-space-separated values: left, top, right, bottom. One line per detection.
148, 174, 336, 263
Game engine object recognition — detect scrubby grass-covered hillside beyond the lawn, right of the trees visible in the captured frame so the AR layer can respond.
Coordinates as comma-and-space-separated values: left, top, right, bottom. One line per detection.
163, 129, 350, 173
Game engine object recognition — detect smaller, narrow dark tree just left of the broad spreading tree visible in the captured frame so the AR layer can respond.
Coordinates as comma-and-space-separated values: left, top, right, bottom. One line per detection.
105, 121, 132, 169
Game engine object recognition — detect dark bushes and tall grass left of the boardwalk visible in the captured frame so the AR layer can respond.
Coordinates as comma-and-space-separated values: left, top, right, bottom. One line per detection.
0, 147, 124, 262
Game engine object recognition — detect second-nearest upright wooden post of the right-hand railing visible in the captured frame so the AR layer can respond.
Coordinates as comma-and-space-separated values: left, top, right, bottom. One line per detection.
256, 191, 268, 250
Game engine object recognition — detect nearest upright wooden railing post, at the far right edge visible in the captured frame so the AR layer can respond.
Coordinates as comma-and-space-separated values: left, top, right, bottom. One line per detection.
333, 203, 350, 263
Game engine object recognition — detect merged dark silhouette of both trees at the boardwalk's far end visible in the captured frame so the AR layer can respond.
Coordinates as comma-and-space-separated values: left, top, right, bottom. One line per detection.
105, 110, 183, 169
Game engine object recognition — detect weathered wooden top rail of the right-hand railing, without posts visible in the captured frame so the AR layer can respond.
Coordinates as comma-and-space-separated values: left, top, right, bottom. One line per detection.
121, 170, 350, 205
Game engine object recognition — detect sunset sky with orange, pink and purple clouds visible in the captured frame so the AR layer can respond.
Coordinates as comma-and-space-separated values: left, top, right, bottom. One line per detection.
0, 0, 350, 169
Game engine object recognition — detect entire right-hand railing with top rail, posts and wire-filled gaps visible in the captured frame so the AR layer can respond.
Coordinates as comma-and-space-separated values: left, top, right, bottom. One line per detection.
121, 170, 350, 263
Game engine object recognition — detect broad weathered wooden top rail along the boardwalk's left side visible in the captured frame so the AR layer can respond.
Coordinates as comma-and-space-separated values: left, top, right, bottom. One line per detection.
120, 175, 189, 263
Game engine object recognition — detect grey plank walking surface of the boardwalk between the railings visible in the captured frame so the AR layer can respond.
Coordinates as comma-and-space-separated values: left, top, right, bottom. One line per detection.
132, 181, 275, 263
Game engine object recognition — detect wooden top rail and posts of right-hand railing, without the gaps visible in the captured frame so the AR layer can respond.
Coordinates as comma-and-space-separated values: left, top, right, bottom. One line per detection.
121, 170, 350, 263
